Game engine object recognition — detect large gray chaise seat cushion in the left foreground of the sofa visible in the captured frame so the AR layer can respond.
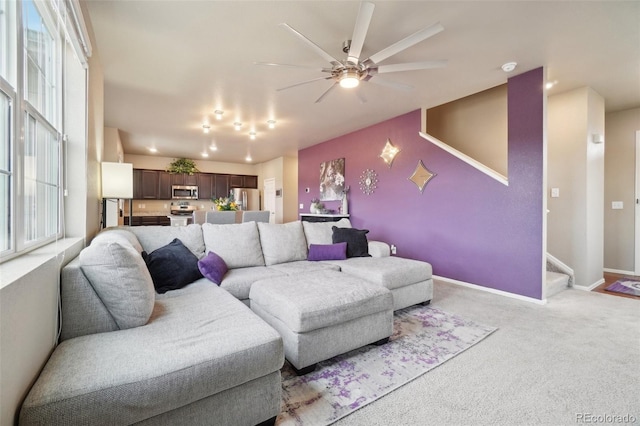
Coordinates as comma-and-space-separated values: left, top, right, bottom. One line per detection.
20, 279, 284, 425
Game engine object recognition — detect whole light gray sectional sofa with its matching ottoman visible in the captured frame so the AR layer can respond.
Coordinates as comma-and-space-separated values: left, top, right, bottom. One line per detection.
19, 220, 433, 425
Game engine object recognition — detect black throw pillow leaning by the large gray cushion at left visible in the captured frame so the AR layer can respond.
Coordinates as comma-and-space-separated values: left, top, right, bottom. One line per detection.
142, 238, 202, 294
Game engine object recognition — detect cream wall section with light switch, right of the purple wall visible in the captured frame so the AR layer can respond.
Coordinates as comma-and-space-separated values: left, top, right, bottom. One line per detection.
547, 87, 604, 287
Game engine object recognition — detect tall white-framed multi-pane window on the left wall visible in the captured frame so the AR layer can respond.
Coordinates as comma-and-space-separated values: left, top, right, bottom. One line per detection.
0, 0, 90, 261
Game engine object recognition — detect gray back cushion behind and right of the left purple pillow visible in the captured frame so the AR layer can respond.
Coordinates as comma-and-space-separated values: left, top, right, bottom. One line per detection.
202, 222, 264, 269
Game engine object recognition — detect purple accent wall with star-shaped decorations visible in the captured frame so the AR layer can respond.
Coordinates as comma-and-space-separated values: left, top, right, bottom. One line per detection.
298, 68, 544, 299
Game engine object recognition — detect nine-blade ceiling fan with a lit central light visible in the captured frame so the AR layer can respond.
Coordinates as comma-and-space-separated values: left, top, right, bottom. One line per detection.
255, 2, 447, 103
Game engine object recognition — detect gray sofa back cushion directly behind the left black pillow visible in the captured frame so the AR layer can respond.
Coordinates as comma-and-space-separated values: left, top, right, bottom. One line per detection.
130, 224, 204, 259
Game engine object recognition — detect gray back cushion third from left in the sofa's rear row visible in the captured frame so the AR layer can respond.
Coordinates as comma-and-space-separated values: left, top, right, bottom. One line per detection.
258, 221, 307, 266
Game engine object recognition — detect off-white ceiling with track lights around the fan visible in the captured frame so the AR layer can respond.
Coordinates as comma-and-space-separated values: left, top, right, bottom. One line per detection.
87, 0, 640, 163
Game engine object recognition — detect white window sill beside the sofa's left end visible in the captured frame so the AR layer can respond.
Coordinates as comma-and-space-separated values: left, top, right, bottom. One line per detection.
0, 238, 84, 289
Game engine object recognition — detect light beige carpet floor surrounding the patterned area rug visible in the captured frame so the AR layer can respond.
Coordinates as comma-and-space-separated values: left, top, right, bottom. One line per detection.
335, 282, 640, 426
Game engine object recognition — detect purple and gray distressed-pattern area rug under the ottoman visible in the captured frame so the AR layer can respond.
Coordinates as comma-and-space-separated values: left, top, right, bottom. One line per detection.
276, 306, 497, 426
